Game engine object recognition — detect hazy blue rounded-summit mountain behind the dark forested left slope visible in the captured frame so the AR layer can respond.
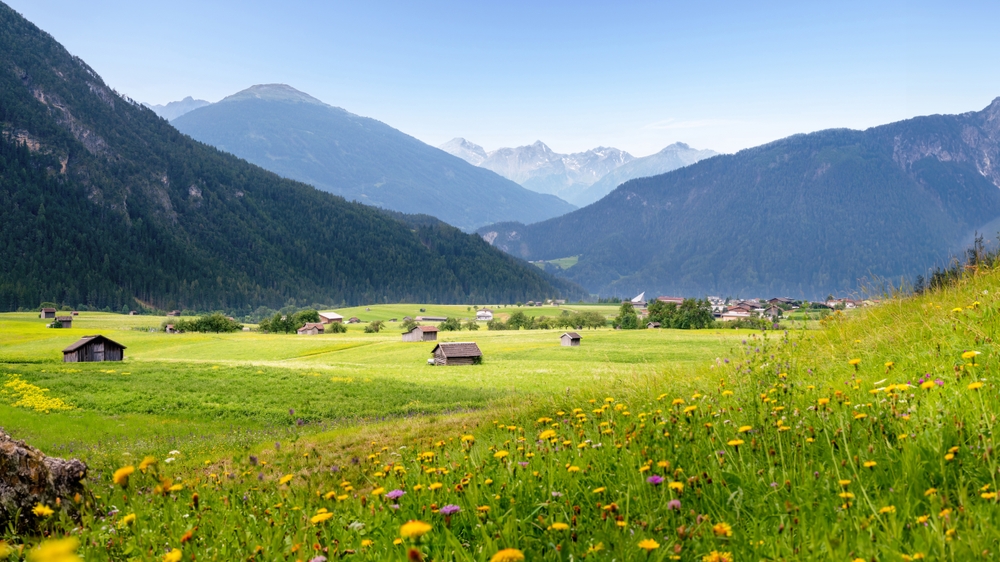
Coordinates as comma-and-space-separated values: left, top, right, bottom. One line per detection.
171, 84, 575, 231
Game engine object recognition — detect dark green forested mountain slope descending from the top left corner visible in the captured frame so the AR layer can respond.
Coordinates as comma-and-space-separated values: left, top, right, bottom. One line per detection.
0, 4, 581, 311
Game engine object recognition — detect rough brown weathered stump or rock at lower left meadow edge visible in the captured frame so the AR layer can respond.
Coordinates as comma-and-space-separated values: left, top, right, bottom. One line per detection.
0, 429, 87, 532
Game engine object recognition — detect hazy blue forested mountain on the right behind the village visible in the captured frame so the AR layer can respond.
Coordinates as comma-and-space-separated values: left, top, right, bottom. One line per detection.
479, 98, 1000, 298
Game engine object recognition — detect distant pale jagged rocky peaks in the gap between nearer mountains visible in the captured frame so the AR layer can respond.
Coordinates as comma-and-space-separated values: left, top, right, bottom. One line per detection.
440, 138, 717, 207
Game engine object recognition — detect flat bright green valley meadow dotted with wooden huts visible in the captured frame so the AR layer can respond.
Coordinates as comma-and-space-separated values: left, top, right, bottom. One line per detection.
0, 306, 734, 454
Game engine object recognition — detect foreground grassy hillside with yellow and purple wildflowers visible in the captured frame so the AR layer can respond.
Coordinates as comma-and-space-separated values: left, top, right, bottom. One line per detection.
0, 266, 1000, 562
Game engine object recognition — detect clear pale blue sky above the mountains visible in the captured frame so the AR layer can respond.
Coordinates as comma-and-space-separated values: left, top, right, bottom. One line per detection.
7, 0, 1000, 156
